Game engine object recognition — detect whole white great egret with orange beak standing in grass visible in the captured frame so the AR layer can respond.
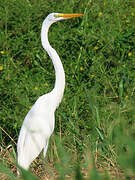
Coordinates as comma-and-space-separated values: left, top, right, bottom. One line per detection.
17, 13, 83, 170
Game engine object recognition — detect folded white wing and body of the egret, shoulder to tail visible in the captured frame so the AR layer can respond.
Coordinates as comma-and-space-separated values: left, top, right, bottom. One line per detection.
17, 96, 54, 169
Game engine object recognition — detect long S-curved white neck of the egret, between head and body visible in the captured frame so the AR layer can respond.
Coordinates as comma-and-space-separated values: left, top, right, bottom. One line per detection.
41, 20, 65, 107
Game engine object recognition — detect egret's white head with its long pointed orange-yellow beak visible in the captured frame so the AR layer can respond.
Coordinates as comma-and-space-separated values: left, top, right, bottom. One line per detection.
47, 13, 83, 23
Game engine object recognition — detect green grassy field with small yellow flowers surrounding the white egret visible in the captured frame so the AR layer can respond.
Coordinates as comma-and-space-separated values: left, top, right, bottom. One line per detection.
0, 0, 135, 180
